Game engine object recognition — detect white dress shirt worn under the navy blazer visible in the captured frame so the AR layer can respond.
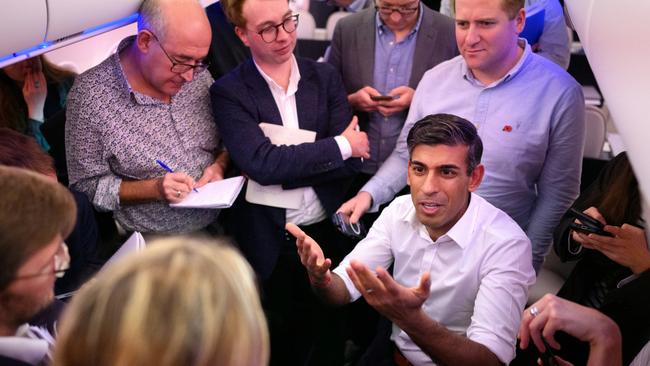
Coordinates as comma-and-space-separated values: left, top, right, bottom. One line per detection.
255, 56, 352, 225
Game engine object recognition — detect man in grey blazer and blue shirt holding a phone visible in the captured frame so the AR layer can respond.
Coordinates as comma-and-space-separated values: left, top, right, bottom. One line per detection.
328, 0, 458, 193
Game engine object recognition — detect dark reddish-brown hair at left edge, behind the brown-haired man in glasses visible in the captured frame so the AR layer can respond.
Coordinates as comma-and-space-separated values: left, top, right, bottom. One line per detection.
0, 127, 56, 176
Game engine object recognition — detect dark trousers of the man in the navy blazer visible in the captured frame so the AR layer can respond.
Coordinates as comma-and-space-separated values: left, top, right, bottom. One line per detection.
262, 219, 354, 366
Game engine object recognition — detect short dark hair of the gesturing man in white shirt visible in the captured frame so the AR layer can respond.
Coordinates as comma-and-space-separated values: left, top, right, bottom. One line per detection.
406, 113, 483, 175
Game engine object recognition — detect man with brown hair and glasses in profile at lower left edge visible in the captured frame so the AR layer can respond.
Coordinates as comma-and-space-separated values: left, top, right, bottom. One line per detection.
0, 166, 77, 365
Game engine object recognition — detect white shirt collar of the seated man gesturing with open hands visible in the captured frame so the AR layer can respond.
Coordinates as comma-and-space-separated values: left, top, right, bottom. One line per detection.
392, 193, 479, 249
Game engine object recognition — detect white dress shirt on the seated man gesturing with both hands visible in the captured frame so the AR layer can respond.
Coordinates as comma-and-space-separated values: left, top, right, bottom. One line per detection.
334, 194, 535, 365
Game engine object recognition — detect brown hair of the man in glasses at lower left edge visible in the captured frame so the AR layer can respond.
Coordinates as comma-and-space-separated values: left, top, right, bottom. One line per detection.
0, 166, 77, 291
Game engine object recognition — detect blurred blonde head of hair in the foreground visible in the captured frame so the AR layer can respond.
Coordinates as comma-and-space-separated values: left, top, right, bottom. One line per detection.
54, 237, 269, 366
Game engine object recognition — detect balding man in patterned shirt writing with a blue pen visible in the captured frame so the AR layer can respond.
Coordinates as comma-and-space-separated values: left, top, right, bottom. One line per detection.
66, 0, 228, 233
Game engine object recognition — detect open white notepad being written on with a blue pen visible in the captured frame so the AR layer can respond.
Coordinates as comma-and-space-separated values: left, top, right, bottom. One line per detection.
169, 176, 244, 208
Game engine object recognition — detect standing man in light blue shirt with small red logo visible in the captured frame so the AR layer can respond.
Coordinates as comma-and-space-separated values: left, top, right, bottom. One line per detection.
339, 0, 585, 270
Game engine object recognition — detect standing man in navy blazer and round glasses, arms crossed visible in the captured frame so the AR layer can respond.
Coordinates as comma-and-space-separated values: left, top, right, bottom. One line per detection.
211, 0, 369, 365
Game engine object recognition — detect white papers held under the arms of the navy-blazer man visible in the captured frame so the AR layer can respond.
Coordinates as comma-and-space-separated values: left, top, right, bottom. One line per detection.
246, 122, 316, 209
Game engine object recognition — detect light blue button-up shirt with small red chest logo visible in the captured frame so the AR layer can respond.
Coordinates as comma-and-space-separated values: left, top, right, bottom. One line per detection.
362, 39, 585, 269
